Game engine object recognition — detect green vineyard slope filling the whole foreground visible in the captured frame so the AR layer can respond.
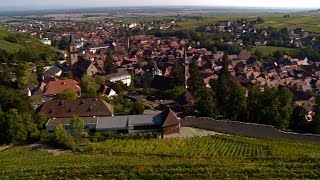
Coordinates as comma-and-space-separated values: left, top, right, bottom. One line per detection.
0, 136, 320, 179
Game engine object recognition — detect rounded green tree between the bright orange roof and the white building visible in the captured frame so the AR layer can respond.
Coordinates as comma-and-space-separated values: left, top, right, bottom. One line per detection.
80, 75, 100, 98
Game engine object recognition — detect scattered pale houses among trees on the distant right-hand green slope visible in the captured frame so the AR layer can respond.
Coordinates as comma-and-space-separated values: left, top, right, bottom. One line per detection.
197, 18, 315, 48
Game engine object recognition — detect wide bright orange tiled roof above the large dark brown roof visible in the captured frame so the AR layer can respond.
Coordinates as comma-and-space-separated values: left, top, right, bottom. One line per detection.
43, 79, 81, 97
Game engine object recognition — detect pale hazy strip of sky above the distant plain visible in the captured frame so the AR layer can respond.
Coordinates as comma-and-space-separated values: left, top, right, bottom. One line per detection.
0, 0, 320, 11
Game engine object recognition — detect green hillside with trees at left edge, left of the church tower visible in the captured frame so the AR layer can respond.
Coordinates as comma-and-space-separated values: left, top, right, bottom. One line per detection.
0, 27, 58, 63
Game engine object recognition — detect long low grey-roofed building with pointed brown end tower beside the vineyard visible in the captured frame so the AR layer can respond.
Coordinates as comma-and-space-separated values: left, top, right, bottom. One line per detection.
46, 109, 181, 135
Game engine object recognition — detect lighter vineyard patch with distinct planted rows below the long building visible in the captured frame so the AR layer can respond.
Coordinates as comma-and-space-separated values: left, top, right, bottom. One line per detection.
93, 136, 271, 158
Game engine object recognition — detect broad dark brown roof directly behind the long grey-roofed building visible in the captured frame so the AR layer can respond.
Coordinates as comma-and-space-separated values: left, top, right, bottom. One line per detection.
39, 99, 114, 118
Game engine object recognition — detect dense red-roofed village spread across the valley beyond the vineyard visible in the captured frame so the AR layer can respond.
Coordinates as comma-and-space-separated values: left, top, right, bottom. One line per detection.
0, 15, 320, 134
